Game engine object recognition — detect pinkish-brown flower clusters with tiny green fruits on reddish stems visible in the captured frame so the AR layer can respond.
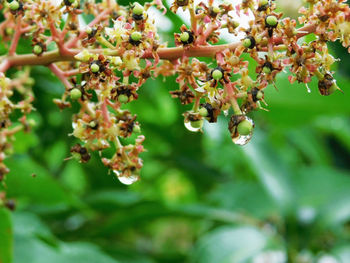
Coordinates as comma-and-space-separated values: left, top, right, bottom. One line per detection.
0, 0, 350, 188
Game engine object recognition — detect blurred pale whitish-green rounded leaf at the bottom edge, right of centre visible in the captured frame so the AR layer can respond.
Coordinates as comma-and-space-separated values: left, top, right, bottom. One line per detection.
191, 226, 267, 263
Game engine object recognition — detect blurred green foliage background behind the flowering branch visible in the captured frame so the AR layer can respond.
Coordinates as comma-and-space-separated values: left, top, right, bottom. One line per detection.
0, 1, 350, 263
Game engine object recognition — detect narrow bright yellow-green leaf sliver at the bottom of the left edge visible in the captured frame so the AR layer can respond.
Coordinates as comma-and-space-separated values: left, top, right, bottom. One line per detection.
0, 208, 13, 263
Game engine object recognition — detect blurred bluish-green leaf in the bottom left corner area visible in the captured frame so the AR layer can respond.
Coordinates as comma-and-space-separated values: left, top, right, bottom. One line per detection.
12, 213, 117, 263
